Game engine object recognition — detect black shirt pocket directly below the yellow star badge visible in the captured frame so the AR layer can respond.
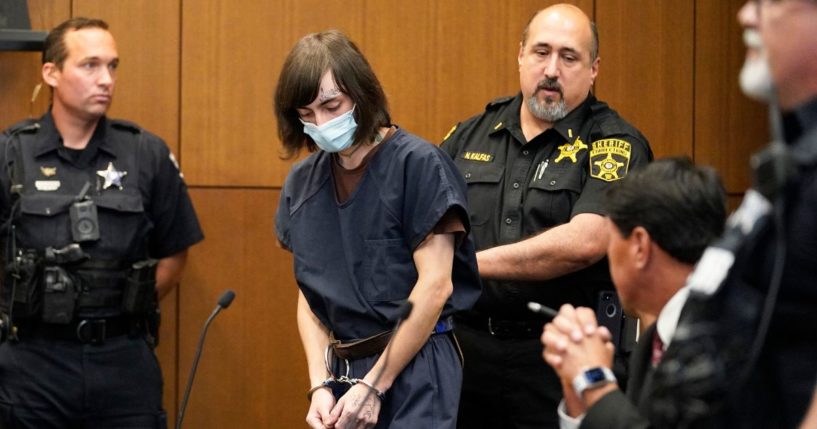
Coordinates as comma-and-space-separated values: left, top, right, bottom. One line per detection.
525, 166, 582, 227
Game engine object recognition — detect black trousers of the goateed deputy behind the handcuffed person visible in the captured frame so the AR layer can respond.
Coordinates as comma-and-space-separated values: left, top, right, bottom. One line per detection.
455, 324, 562, 429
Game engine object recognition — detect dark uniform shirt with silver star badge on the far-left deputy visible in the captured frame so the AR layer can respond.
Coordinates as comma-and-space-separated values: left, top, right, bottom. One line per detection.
0, 113, 203, 312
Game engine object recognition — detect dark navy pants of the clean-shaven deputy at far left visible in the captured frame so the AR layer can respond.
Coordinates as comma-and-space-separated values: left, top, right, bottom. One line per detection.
0, 335, 167, 429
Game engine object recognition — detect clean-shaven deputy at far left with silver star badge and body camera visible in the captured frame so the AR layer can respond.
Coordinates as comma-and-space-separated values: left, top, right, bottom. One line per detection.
0, 18, 203, 429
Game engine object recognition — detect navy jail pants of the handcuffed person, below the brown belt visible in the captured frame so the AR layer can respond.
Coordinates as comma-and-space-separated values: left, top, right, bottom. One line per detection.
333, 334, 462, 429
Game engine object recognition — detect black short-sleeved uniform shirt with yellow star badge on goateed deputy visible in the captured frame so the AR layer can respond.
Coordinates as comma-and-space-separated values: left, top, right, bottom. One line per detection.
442, 94, 652, 318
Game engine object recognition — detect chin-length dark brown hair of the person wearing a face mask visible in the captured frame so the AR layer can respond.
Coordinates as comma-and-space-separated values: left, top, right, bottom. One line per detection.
275, 30, 391, 159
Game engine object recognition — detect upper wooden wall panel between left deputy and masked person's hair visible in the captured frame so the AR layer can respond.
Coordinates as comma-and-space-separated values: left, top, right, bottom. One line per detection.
182, 0, 363, 186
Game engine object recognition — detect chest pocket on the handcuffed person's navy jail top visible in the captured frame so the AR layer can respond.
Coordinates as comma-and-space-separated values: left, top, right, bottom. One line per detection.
362, 238, 417, 302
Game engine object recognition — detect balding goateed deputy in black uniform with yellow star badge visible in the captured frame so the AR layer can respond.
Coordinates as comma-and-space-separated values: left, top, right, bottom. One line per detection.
442, 4, 652, 429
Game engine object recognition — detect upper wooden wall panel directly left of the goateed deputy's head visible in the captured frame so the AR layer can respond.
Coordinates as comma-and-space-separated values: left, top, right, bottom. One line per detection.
428, 0, 593, 143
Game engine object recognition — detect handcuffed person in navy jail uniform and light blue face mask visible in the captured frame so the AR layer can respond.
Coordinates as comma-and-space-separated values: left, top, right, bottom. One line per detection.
275, 31, 480, 429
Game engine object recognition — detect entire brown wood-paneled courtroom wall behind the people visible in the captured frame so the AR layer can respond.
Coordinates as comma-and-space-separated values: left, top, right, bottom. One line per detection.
0, 0, 767, 428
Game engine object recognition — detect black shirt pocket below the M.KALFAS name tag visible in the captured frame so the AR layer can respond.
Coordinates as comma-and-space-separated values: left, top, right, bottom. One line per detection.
455, 158, 505, 226
